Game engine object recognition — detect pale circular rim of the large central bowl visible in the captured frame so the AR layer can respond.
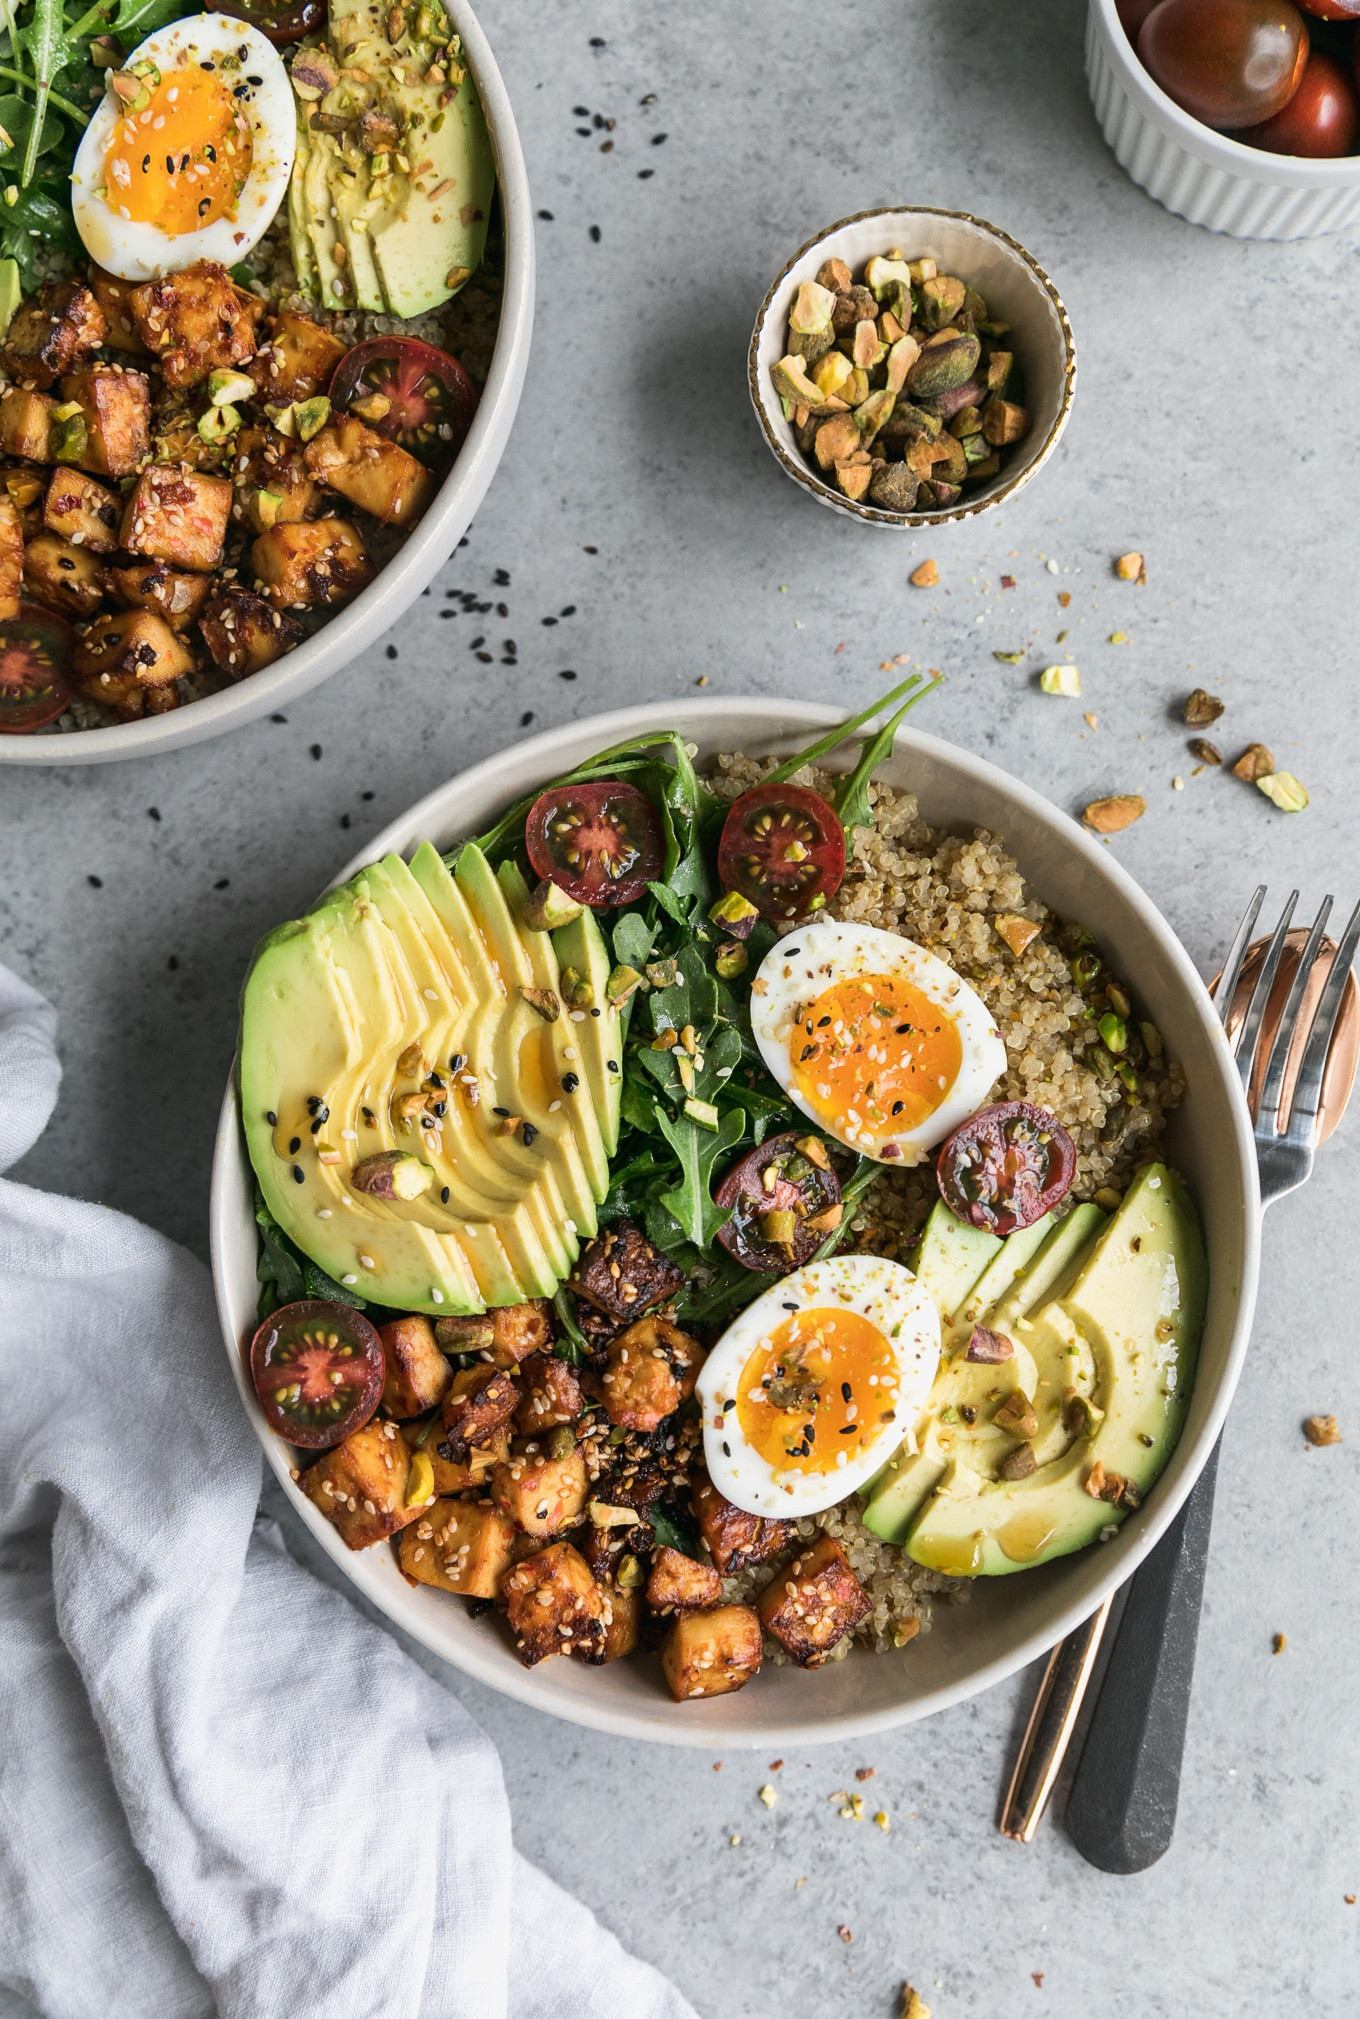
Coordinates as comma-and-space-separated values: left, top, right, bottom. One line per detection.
210, 697, 1261, 1748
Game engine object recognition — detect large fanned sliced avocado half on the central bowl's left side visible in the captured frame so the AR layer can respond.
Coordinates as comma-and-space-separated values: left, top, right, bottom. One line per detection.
240, 844, 621, 1316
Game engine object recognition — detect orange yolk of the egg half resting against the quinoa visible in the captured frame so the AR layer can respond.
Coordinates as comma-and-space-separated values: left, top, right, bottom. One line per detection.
789, 975, 962, 1139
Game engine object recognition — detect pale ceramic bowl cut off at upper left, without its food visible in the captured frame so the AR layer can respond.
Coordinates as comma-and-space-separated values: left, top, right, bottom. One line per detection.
0, 0, 535, 765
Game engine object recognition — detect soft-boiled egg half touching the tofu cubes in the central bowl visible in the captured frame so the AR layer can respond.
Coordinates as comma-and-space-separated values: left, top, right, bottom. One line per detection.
698, 1256, 940, 1516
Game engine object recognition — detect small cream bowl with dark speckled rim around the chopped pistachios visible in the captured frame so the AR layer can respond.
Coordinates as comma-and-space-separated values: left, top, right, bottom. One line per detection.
747, 210, 1078, 527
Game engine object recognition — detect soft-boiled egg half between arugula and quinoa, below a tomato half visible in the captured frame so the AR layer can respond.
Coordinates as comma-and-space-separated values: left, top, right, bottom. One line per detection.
751, 919, 1007, 1163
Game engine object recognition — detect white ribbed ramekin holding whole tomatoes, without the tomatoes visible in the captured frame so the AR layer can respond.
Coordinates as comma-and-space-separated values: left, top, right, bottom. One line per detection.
1086, 0, 1360, 238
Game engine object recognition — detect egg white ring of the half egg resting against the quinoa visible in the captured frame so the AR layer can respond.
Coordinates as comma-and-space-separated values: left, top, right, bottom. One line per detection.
751, 919, 1007, 1163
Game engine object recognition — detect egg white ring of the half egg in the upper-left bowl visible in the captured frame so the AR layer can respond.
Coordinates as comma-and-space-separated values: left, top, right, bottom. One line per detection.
71, 14, 297, 281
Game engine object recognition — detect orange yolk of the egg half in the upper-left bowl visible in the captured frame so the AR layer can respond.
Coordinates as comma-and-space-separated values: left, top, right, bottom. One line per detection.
105, 71, 252, 238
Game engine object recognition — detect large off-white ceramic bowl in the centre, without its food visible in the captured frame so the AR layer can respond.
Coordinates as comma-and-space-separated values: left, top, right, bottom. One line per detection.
212, 701, 1259, 1748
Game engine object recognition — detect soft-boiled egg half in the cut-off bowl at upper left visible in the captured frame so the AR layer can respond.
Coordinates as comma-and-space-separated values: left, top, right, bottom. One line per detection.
71, 14, 297, 281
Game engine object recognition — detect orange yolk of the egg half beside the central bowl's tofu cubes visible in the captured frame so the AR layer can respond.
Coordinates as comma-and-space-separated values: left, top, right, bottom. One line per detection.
736, 1306, 898, 1474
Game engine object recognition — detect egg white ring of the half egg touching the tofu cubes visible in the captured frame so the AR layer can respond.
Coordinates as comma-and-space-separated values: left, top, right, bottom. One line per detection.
696, 1256, 940, 1518
